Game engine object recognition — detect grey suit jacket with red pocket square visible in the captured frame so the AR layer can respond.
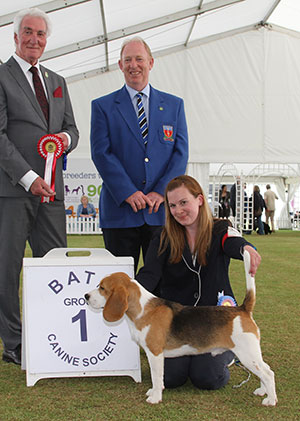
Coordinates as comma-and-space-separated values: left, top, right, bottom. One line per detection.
0, 57, 78, 200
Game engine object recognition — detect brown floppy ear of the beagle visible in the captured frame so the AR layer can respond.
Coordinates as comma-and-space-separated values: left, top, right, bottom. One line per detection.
103, 285, 128, 322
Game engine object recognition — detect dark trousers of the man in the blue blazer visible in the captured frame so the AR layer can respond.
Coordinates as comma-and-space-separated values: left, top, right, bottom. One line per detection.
102, 224, 158, 274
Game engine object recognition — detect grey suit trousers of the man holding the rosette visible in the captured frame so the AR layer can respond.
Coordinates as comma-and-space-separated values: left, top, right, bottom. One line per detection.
0, 197, 67, 349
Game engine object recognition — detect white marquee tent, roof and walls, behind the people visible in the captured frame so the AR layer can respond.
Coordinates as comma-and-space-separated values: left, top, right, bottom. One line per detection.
0, 0, 300, 226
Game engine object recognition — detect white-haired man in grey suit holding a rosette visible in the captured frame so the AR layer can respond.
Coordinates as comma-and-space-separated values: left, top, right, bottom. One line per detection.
0, 8, 78, 364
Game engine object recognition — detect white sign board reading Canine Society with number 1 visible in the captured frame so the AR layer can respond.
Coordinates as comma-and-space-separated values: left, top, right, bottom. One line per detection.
22, 249, 141, 386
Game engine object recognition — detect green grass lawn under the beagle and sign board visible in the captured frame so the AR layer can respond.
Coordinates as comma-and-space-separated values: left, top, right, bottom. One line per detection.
0, 230, 300, 421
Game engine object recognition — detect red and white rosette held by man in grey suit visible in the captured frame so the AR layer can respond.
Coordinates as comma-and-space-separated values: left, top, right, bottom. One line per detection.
37, 134, 64, 202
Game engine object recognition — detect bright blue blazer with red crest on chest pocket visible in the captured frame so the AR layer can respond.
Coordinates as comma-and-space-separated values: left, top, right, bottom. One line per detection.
91, 86, 188, 228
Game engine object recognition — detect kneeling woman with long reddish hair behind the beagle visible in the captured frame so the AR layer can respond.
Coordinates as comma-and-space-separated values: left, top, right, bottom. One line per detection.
136, 175, 261, 389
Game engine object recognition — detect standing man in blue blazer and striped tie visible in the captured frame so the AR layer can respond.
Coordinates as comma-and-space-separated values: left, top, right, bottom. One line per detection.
91, 37, 188, 270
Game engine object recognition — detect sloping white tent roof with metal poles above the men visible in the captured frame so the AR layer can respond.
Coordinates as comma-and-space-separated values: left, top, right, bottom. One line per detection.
0, 0, 300, 82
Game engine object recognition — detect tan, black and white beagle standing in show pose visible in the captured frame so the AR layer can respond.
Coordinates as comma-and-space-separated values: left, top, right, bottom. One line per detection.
85, 251, 277, 406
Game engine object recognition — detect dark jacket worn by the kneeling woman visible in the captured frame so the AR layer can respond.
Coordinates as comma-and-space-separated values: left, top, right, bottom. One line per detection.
136, 220, 251, 305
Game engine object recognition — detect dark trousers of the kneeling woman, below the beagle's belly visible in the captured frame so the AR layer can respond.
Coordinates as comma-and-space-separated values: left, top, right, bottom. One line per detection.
164, 351, 234, 390
